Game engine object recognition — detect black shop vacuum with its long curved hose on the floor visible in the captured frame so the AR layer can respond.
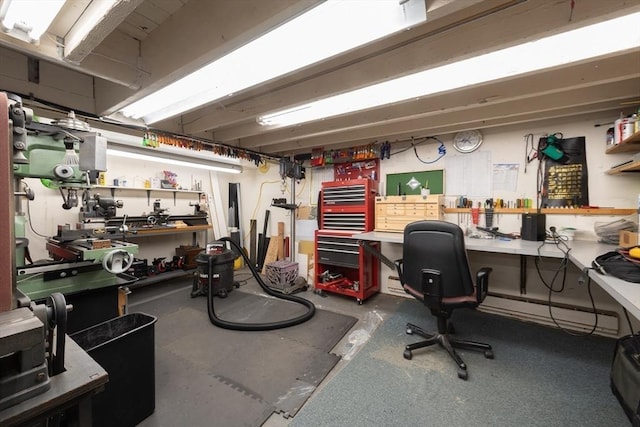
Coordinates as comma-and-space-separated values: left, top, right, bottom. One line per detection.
191, 237, 316, 331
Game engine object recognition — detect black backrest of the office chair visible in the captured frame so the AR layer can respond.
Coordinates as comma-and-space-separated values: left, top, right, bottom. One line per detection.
402, 220, 474, 298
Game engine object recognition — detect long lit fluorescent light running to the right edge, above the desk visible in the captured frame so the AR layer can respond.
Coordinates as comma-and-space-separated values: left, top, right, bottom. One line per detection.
257, 13, 640, 126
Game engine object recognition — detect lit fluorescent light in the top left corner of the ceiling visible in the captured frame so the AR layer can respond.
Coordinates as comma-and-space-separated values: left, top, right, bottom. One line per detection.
0, 0, 65, 43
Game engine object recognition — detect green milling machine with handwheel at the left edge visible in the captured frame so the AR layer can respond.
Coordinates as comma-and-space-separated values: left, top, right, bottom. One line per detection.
9, 95, 138, 310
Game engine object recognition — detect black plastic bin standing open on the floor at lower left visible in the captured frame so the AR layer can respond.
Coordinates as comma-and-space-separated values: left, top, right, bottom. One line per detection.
70, 313, 158, 427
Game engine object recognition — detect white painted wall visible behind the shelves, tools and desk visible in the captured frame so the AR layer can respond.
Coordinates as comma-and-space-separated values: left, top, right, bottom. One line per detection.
21, 112, 640, 331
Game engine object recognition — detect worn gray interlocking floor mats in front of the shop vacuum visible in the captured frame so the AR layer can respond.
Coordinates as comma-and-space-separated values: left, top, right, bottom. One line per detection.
129, 285, 356, 426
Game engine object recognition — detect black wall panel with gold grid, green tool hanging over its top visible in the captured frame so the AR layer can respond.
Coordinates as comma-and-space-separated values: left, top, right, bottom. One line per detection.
538, 135, 589, 208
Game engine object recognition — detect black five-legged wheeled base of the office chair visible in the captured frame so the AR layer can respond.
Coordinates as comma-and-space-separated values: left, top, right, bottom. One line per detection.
403, 323, 493, 380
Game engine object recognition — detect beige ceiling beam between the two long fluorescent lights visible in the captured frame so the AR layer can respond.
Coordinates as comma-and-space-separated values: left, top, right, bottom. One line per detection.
183, 0, 640, 133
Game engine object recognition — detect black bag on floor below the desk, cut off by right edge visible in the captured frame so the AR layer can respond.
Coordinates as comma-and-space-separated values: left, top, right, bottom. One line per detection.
610, 334, 640, 427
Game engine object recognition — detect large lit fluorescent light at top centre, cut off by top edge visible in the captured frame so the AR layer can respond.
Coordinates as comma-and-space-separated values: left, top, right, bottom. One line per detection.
120, 0, 426, 124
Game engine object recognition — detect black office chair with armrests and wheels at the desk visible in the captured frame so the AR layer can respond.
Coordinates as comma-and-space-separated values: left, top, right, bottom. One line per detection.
395, 221, 493, 380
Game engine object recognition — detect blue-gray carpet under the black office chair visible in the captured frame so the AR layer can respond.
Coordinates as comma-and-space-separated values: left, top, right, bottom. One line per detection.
290, 301, 629, 427
